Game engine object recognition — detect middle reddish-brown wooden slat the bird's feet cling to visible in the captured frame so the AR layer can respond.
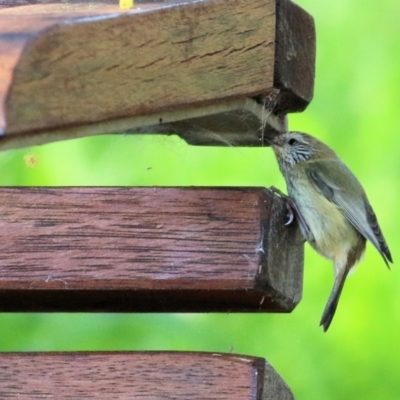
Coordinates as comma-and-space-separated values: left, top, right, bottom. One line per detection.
0, 188, 303, 312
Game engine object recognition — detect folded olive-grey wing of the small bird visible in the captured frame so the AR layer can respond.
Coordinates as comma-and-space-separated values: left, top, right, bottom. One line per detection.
306, 160, 393, 266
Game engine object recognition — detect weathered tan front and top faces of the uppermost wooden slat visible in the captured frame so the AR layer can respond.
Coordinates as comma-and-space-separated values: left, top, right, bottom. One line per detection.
0, 0, 275, 135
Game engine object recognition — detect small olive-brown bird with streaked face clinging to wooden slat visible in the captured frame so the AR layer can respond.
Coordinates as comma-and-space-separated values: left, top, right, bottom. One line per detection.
266, 132, 393, 332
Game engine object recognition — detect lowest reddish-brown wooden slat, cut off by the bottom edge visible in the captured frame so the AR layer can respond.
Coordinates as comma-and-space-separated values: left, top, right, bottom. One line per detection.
0, 352, 293, 400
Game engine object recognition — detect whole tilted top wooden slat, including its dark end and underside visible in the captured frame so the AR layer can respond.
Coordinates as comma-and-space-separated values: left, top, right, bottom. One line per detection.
0, 0, 315, 150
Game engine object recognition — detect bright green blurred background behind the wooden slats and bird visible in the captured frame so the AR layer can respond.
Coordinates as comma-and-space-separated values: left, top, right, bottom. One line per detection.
0, 0, 400, 400
